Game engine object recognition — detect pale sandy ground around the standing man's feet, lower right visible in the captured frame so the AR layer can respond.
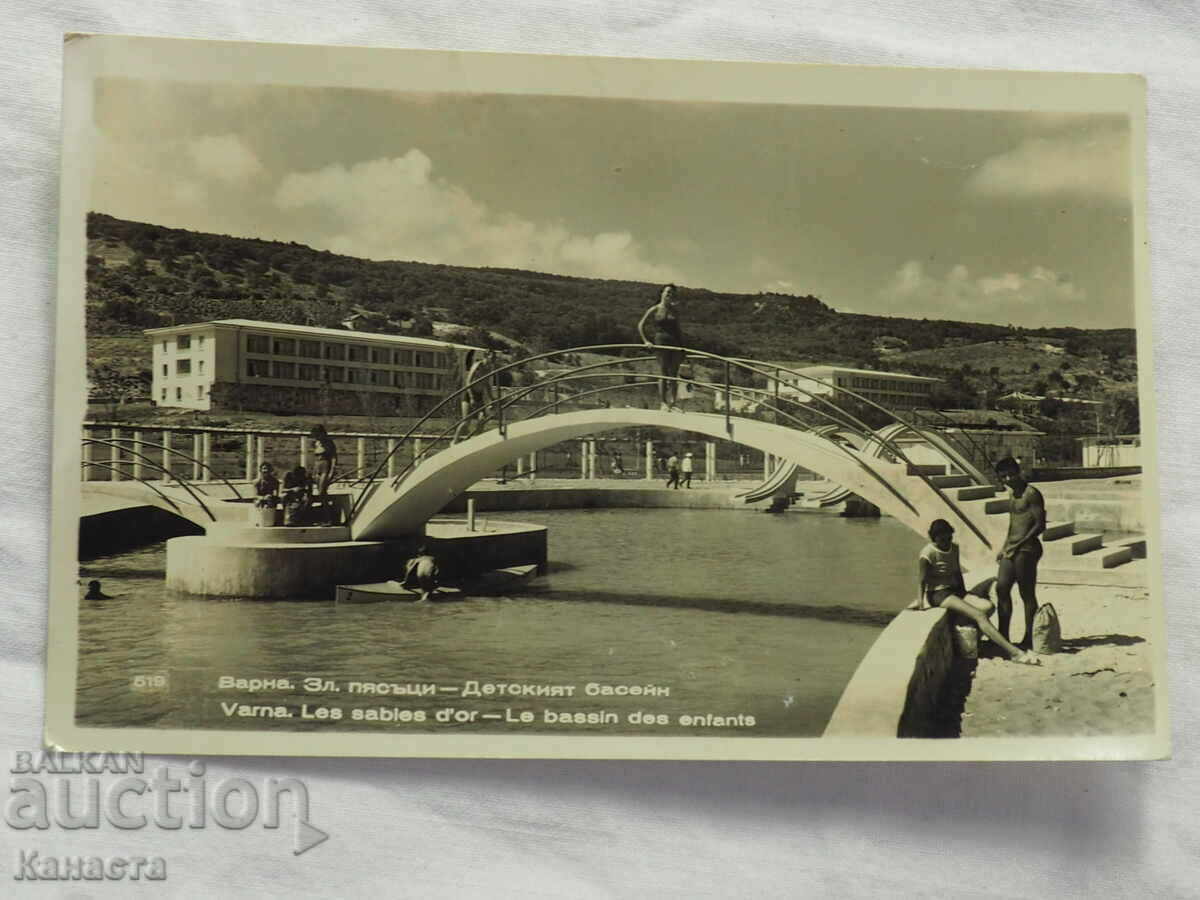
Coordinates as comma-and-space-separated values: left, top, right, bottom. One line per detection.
961, 584, 1154, 737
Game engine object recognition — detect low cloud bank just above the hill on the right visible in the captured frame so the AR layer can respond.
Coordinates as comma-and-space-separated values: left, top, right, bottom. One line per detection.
880, 259, 1087, 326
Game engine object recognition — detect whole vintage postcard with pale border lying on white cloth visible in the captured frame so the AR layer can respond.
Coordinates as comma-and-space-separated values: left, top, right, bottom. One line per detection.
47, 36, 1169, 760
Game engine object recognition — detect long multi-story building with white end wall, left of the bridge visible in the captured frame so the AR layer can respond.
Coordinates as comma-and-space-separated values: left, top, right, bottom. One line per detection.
145, 319, 479, 415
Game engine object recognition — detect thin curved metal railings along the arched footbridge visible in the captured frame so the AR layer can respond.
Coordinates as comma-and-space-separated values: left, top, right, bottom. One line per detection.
350, 344, 991, 547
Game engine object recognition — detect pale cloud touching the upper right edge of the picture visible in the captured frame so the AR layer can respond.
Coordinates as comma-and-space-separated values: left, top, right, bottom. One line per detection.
966, 131, 1129, 202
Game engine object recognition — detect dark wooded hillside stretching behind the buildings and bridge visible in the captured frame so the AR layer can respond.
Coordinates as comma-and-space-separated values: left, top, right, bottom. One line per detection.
86, 212, 1136, 420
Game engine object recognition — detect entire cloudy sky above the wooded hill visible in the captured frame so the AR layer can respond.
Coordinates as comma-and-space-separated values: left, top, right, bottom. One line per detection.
91, 79, 1134, 328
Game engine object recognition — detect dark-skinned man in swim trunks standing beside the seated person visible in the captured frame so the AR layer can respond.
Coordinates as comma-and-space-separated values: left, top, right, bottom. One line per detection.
996, 456, 1046, 650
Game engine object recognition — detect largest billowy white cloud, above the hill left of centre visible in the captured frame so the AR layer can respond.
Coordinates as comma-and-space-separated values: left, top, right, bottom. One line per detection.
275, 148, 680, 281
